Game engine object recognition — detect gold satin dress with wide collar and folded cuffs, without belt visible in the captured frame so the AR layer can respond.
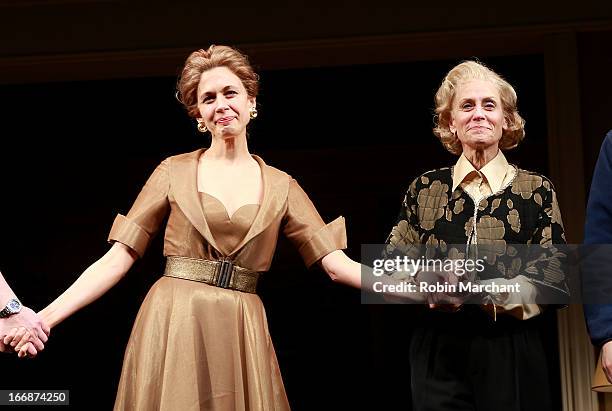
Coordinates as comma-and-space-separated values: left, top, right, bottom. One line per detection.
109, 150, 346, 411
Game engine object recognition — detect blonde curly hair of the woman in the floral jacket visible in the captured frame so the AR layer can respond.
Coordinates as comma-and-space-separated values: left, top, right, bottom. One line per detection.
433, 60, 525, 155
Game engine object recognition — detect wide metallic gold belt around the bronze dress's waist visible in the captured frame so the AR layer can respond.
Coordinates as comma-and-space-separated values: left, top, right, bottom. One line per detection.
164, 257, 260, 293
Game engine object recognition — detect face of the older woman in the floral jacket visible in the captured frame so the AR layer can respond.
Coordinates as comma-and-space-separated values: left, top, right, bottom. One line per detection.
450, 80, 507, 151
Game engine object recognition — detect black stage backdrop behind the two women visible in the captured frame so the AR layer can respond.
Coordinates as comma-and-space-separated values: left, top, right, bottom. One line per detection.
0, 55, 561, 410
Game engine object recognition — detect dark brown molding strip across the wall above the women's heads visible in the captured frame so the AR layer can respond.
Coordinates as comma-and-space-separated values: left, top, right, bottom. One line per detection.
0, 20, 612, 84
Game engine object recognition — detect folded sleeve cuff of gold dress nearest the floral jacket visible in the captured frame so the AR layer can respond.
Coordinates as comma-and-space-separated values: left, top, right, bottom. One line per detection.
299, 217, 346, 267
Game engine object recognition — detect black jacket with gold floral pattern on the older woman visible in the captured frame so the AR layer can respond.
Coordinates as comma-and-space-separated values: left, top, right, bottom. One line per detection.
387, 168, 567, 292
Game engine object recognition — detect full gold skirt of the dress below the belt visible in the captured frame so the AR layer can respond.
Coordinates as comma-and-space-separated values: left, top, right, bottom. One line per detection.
114, 277, 289, 411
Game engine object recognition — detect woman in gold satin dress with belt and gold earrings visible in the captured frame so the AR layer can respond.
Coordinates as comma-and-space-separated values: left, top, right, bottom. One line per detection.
11, 46, 361, 411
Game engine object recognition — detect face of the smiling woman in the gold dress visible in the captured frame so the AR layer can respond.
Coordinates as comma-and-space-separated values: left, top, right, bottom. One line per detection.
198, 67, 255, 138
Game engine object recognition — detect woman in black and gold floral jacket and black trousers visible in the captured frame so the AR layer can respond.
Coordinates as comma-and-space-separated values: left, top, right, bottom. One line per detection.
385, 61, 567, 411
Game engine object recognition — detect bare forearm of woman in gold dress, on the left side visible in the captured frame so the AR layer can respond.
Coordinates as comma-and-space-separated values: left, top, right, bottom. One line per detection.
40, 244, 134, 327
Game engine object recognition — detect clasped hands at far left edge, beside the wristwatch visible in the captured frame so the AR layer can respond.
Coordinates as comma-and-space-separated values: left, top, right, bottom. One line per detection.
0, 307, 51, 358
